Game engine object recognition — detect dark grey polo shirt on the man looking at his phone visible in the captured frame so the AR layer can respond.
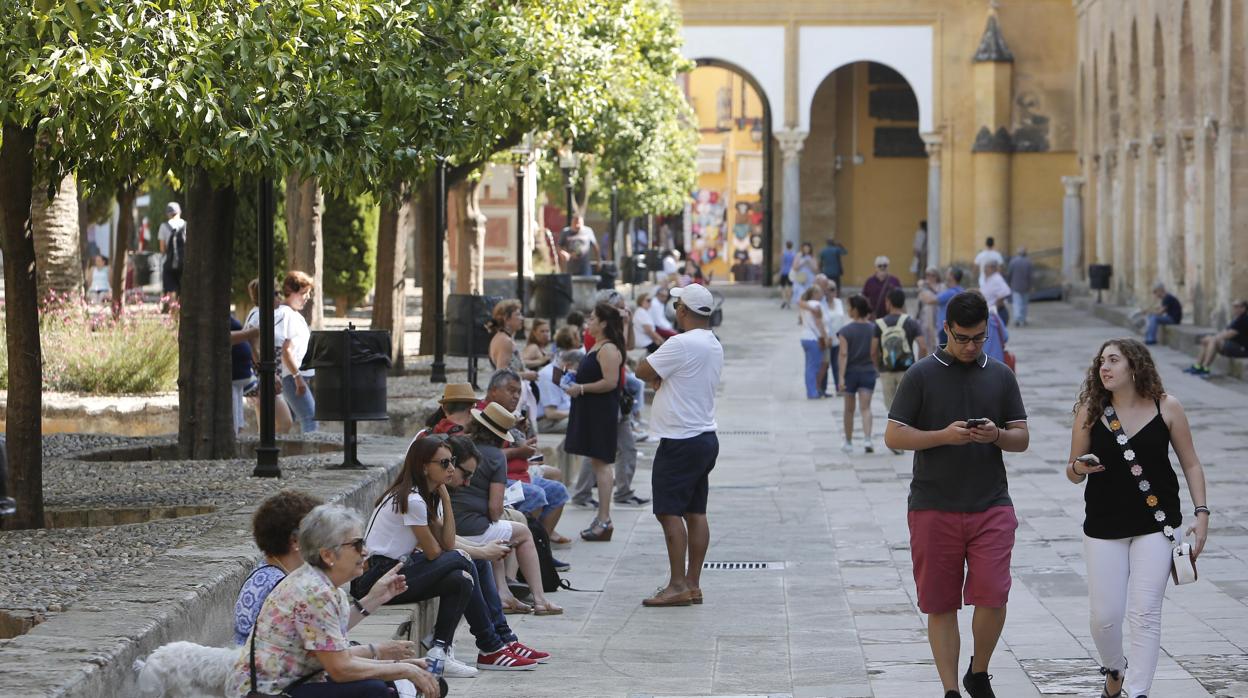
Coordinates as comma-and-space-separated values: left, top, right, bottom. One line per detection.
889, 347, 1027, 512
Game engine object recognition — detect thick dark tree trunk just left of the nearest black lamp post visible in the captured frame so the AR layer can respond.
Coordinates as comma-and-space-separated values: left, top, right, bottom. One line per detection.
177, 171, 238, 460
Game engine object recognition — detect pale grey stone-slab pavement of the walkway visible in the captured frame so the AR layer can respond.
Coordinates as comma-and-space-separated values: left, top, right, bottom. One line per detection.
354, 292, 1248, 698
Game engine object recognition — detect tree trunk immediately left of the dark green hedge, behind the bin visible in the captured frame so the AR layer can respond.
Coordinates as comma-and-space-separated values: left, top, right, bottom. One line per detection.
286, 174, 324, 330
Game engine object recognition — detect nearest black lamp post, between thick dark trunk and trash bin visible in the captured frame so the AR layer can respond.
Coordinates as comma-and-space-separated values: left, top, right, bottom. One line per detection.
251, 177, 282, 477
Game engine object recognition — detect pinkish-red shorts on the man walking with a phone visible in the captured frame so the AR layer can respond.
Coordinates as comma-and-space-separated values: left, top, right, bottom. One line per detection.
907, 506, 1018, 613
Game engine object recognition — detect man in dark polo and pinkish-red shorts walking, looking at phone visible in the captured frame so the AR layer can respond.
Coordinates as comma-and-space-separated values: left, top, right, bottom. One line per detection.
884, 292, 1030, 698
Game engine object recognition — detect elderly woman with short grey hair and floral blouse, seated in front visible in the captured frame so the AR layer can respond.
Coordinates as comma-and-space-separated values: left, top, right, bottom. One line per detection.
227, 504, 442, 698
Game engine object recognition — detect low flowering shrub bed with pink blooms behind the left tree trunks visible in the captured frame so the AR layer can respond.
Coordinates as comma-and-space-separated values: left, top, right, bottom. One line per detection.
0, 293, 177, 395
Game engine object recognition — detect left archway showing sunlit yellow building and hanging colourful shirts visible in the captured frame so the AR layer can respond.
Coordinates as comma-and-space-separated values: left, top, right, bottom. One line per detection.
679, 59, 775, 286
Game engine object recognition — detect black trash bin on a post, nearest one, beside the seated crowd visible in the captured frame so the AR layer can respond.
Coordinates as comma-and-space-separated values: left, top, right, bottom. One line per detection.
301, 323, 391, 468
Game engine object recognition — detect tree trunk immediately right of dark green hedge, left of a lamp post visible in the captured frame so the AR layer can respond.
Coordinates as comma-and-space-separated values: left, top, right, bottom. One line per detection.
372, 182, 413, 372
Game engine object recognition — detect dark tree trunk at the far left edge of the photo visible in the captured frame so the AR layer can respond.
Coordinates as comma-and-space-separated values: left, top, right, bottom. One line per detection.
0, 124, 43, 528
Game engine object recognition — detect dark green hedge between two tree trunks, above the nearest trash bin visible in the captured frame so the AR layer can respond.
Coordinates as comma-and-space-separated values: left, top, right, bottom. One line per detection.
321, 194, 381, 312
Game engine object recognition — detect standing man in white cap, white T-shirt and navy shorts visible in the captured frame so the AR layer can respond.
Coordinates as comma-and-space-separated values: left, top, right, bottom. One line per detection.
636, 283, 724, 607
